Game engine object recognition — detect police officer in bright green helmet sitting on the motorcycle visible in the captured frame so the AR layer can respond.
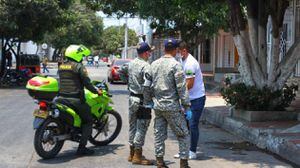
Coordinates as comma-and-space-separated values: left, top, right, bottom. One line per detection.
57, 45, 102, 155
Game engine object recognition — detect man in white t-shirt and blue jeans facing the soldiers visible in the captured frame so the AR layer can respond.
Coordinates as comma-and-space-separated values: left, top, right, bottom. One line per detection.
175, 42, 206, 159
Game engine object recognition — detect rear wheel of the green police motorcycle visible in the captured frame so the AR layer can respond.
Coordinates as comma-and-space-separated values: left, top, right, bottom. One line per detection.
34, 118, 64, 159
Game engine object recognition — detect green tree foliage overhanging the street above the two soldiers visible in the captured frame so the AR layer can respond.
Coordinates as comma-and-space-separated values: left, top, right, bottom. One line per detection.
85, 0, 228, 41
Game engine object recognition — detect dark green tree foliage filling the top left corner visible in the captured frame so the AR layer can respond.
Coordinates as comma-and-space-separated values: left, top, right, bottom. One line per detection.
0, 0, 72, 41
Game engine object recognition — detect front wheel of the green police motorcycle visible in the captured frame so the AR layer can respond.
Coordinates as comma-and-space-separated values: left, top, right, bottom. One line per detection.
90, 111, 122, 146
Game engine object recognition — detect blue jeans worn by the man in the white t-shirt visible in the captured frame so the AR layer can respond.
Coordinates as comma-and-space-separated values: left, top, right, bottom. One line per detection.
189, 96, 206, 152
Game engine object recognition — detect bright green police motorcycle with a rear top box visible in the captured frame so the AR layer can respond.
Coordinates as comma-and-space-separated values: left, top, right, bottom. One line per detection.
26, 76, 122, 159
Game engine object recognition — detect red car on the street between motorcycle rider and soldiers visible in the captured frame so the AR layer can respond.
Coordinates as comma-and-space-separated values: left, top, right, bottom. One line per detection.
107, 59, 131, 83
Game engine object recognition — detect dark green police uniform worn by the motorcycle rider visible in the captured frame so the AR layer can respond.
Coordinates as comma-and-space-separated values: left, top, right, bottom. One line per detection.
58, 60, 98, 147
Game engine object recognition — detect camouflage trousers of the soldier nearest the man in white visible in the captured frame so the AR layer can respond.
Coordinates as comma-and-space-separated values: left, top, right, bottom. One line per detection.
154, 110, 189, 159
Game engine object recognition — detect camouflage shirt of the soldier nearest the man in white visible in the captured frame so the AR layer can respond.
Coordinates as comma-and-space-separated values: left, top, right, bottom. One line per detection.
151, 56, 190, 111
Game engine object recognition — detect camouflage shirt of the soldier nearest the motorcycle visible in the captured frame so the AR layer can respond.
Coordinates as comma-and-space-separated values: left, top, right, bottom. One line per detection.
128, 57, 150, 97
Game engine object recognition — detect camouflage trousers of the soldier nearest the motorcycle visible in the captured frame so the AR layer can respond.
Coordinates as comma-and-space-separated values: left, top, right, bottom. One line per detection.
129, 96, 151, 148
